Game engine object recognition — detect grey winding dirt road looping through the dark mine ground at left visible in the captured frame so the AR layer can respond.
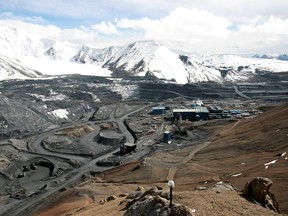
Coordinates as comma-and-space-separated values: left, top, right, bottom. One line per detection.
3, 105, 150, 216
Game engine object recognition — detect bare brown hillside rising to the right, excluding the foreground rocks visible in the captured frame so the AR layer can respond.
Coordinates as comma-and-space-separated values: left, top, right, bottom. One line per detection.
32, 104, 288, 216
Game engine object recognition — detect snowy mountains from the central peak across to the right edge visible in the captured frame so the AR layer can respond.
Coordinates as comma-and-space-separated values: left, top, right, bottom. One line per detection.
71, 41, 288, 83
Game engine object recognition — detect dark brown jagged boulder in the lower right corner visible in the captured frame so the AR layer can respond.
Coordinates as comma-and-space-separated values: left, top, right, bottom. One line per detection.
243, 177, 280, 213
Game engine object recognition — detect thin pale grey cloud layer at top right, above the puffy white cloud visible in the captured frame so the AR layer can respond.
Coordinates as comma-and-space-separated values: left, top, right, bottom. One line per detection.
121, 0, 288, 22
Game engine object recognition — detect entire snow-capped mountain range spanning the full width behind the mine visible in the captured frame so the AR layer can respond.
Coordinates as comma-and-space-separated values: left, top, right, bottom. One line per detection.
0, 20, 288, 84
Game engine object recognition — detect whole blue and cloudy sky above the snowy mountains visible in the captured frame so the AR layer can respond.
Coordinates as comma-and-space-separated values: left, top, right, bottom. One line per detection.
0, 0, 288, 55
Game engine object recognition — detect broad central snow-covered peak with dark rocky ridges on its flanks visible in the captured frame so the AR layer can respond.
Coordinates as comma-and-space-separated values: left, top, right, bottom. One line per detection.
71, 41, 243, 83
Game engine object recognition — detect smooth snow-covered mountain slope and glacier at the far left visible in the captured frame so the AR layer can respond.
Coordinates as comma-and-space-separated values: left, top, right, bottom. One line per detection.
0, 22, 111, 80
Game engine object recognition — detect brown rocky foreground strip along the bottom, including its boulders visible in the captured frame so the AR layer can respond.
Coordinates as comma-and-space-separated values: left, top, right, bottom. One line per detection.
36, 178, 279, 216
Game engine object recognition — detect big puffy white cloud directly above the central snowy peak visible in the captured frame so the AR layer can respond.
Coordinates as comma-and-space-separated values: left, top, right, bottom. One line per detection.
99, 8, 232, 51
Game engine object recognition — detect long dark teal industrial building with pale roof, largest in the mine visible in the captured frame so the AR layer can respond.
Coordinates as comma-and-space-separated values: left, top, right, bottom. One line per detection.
173, 106, 209, 121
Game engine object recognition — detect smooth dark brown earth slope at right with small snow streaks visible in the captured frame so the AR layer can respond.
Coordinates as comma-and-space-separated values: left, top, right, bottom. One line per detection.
195, 104, 288, 213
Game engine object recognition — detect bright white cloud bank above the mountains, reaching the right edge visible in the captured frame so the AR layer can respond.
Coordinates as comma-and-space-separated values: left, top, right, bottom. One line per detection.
114, 8, 288, 53
